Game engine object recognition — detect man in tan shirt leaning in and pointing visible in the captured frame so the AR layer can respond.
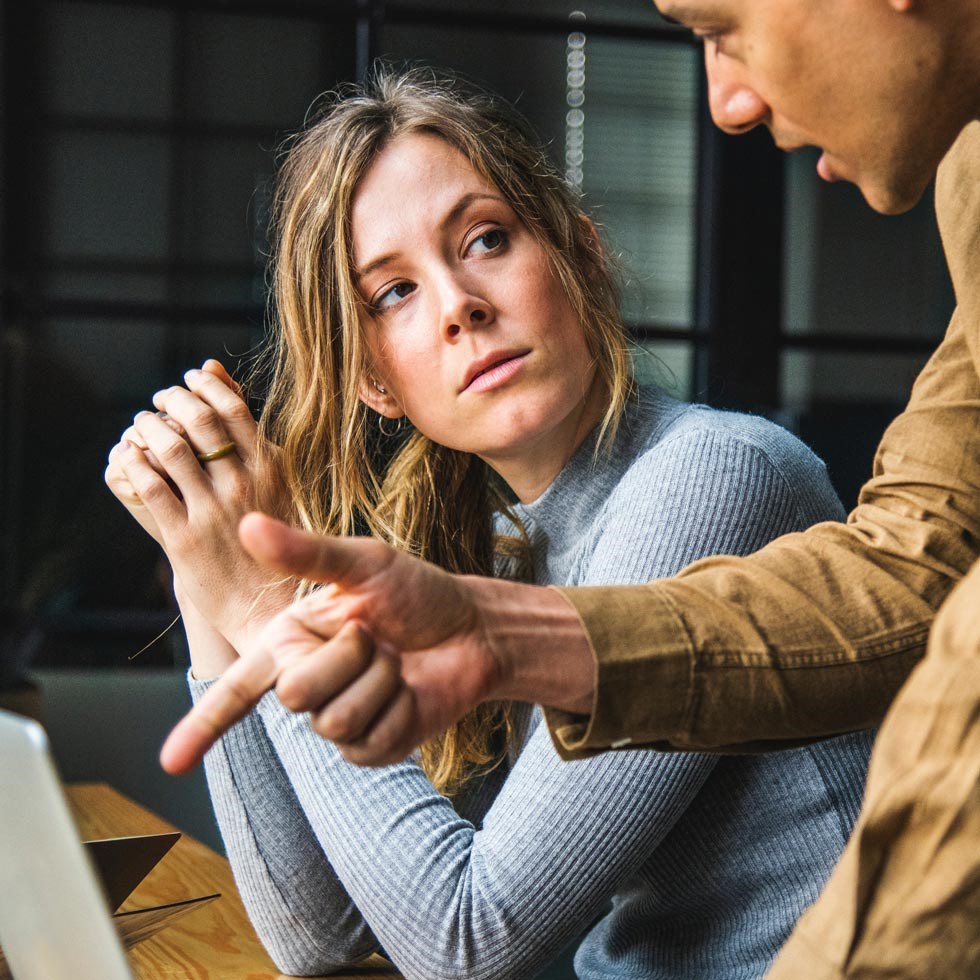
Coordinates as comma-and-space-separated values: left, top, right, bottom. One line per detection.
164, 0, 980, 980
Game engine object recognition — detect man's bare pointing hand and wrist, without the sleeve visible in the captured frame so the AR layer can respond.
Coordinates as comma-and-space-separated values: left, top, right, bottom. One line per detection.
161, 514, 595, 773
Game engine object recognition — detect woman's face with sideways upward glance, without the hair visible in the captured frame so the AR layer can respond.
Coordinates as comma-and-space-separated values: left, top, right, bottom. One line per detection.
352, 134, 606, 500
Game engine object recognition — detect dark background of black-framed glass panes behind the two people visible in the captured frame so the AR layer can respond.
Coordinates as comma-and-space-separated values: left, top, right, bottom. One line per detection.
0, 0, 952, 964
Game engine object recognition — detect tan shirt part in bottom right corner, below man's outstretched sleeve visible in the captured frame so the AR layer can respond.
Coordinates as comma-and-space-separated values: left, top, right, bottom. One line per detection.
768, 562, 980, 980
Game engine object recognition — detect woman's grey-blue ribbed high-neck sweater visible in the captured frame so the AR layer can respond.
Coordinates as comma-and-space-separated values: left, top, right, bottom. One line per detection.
191, 389, 871, 980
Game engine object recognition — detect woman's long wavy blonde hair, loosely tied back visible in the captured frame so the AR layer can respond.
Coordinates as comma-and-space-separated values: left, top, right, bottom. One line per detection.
261, 68, 630, 795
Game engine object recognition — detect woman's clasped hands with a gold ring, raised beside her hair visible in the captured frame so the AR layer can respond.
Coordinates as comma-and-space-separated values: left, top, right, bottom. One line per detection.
105, 360, 295, 666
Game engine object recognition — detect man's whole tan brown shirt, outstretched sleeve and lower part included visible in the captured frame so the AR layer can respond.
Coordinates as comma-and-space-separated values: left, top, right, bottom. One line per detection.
548, 123, 980, 980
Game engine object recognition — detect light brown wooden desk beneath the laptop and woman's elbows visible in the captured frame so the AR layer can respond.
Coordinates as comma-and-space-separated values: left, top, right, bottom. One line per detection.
67, 783, 399, 980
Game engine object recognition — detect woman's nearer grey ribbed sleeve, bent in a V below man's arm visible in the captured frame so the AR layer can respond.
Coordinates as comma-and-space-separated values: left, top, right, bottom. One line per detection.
253, 705, 714, 980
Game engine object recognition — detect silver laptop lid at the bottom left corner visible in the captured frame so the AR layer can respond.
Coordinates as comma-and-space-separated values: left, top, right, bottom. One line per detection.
0, 711, 132, 980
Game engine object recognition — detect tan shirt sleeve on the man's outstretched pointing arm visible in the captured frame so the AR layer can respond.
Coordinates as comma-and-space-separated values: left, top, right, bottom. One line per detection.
548, 130, 980, 757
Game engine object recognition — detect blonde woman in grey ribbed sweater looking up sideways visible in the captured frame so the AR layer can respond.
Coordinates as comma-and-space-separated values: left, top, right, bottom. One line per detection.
107, 74, 870, 980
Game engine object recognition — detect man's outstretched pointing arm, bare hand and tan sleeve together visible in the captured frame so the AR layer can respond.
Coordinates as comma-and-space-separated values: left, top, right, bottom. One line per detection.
164, 284, 980, 771
